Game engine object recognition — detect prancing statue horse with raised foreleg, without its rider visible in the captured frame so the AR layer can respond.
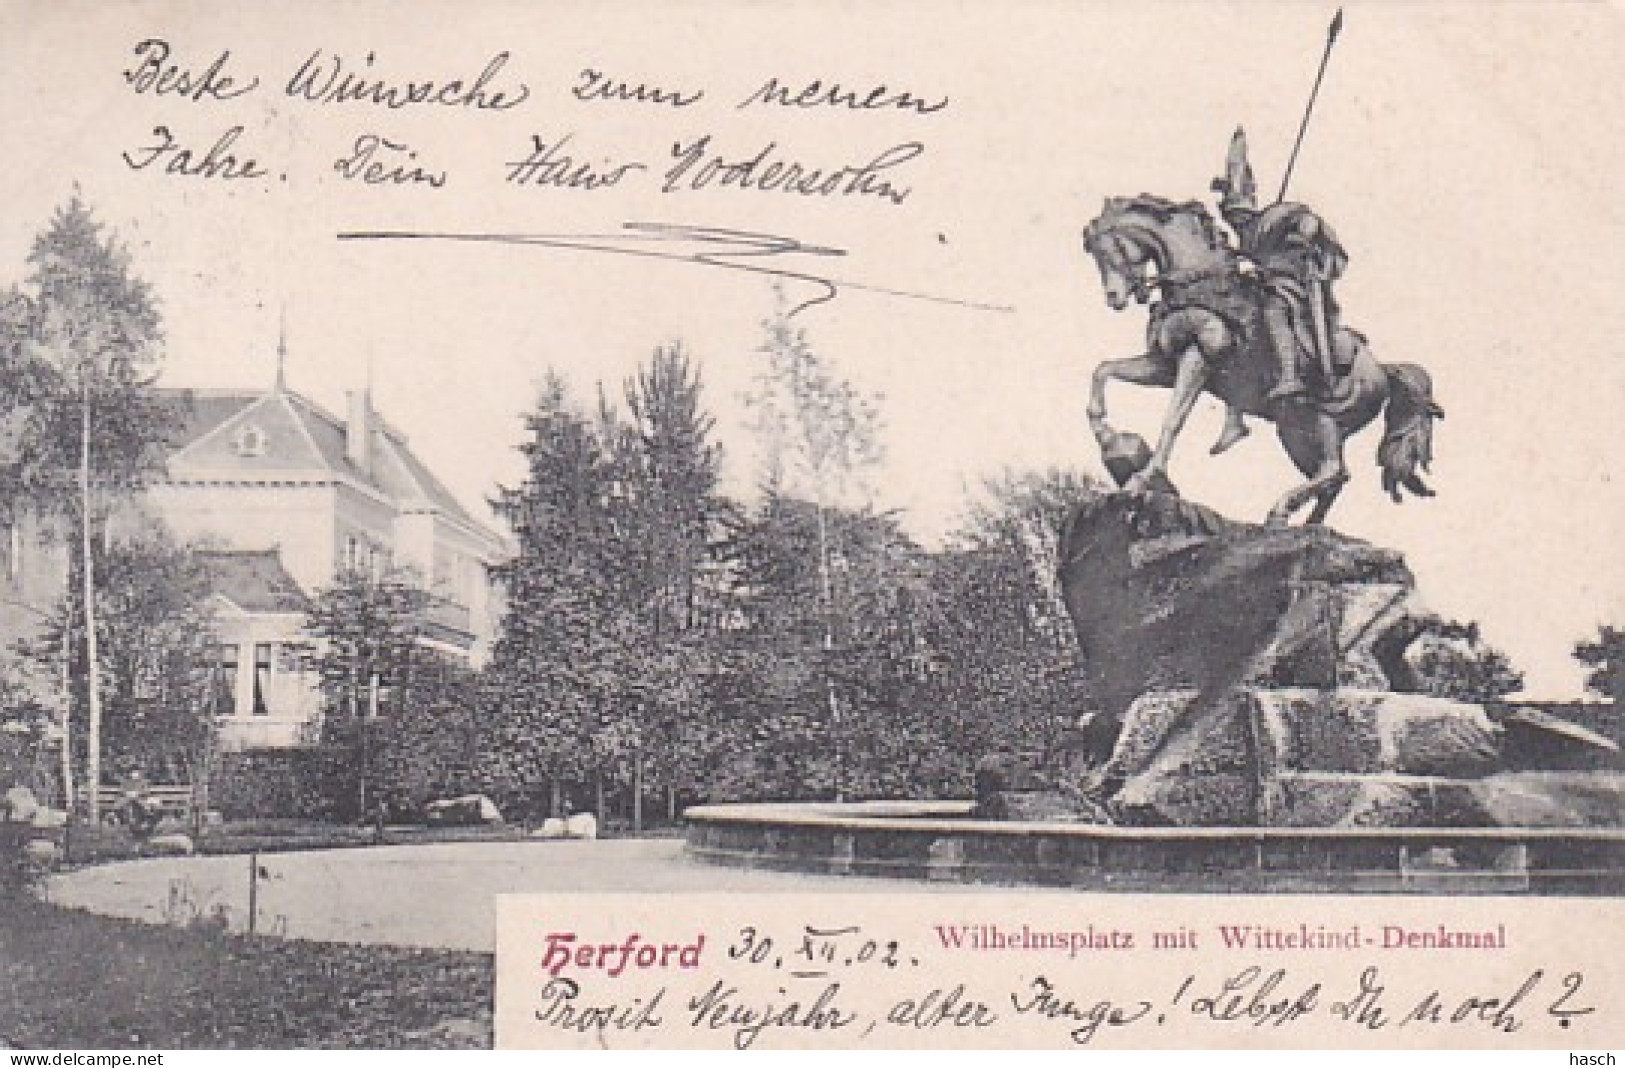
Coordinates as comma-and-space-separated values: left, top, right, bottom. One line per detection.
1084, 195, 1445, 525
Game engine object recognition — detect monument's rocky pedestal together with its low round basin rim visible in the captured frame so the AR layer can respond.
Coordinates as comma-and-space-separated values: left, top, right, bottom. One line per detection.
686, 490, 1625, 894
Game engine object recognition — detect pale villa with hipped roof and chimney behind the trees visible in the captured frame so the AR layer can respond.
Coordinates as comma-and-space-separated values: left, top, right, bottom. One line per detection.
0, 346, 507, 749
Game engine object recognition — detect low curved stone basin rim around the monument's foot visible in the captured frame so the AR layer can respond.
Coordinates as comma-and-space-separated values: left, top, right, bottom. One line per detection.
686, 801, 1625, 896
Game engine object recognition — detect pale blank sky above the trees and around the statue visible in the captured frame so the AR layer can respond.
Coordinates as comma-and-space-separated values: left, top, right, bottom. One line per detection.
0, 0, 1625, 697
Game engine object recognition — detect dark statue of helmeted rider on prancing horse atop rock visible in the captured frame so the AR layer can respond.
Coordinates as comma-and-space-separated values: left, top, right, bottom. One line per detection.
1084, 130, 1445, 525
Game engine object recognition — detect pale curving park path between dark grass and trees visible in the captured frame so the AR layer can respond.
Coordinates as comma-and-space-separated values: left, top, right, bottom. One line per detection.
47, 839, 981, 951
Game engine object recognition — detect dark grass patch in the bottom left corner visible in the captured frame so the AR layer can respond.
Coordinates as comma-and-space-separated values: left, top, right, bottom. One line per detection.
0, 891, 492, 1048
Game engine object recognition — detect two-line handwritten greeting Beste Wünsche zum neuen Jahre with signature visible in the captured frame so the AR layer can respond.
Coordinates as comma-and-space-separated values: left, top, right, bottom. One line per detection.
122, 37, 949, 206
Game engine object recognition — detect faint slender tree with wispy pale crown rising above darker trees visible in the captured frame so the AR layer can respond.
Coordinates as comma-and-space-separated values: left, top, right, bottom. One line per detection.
748, 288, 881, 800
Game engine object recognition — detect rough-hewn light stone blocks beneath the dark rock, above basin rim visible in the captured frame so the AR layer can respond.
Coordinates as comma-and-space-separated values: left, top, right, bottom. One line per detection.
1097, 688, 1625, 827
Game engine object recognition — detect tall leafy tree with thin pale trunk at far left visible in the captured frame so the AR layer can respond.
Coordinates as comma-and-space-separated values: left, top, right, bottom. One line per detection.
0, 195, 172, 821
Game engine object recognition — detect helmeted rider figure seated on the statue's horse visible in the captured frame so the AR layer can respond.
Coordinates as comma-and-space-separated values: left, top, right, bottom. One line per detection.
1212, 128, 1349, 452
